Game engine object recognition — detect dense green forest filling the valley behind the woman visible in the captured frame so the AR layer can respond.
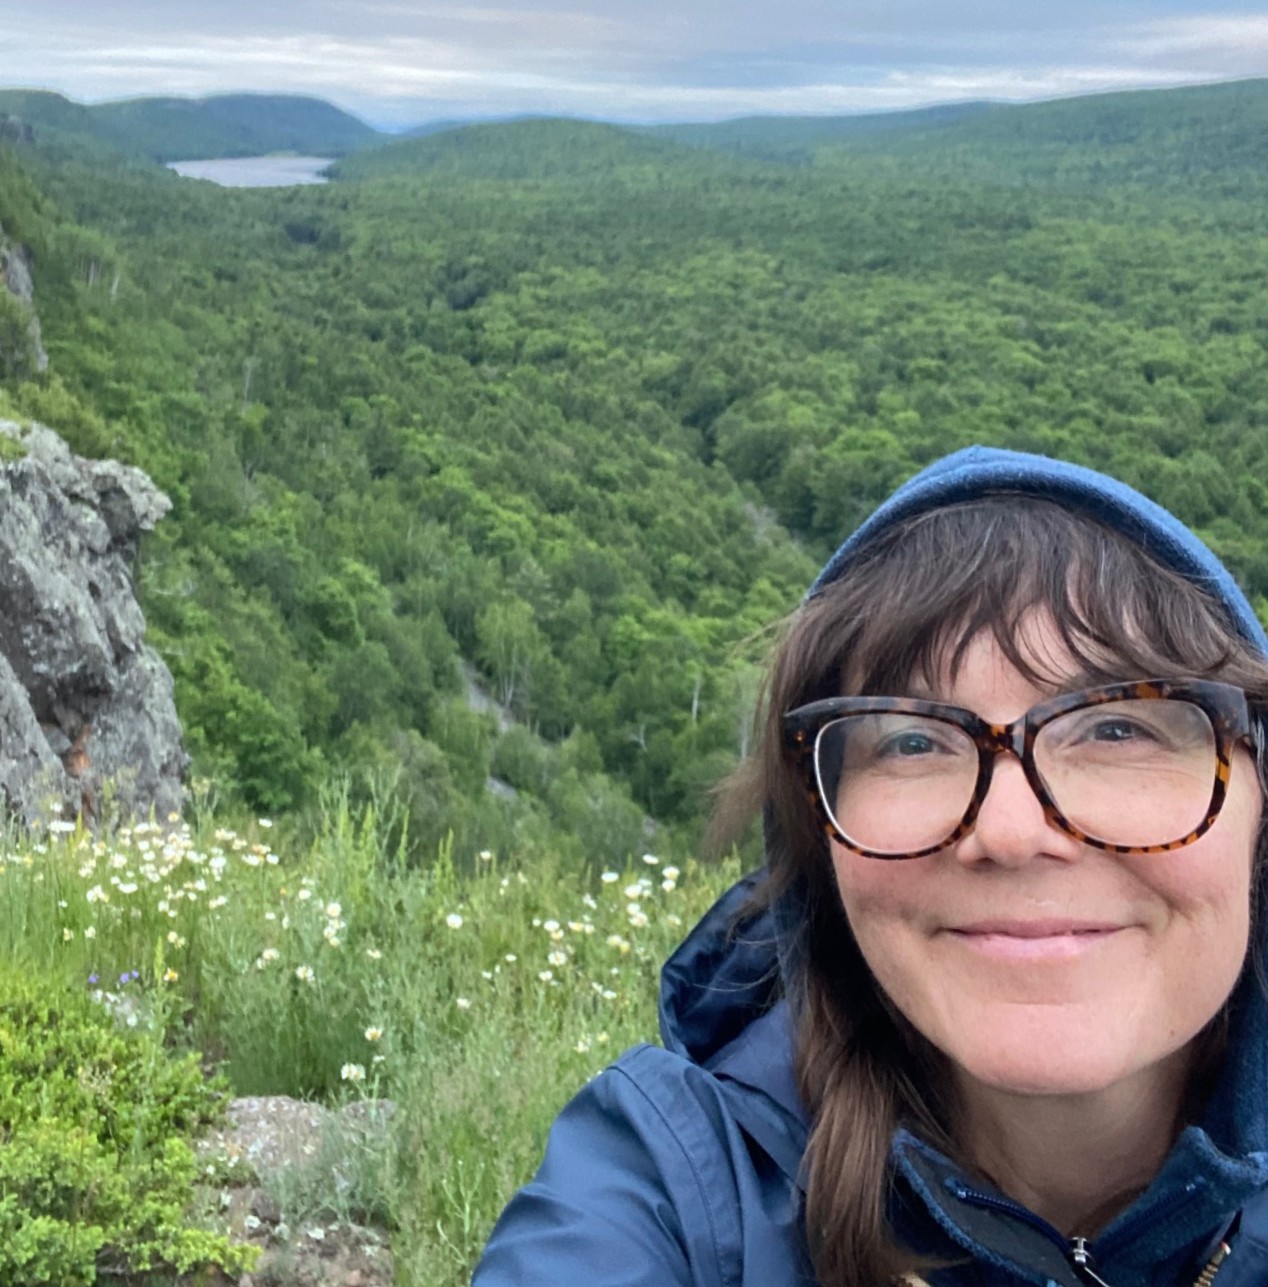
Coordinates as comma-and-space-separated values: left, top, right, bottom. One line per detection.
0, 75, 1268, 866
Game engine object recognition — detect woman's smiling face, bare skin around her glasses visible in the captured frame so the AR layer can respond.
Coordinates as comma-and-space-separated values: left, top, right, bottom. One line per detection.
833, 620, 1260, 1095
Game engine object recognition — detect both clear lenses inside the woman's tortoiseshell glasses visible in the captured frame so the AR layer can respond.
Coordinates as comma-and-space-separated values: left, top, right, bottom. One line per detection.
815, 699, 1217, 855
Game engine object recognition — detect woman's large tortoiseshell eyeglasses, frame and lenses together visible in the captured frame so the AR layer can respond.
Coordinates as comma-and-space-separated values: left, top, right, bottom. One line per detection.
784, 680, 1254, 858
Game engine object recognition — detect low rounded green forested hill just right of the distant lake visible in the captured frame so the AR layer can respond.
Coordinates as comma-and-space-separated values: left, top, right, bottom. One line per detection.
335, 117, 720, 180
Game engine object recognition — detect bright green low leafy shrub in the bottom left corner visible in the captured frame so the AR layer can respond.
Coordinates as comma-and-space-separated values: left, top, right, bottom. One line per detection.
0, 967, 254, 1287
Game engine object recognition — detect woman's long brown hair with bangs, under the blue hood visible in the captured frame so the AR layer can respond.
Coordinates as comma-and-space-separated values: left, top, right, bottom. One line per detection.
718, 494, 1268, 1287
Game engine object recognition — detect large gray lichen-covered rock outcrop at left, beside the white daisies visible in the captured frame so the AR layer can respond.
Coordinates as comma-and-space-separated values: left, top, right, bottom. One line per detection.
0, 421, 187, 824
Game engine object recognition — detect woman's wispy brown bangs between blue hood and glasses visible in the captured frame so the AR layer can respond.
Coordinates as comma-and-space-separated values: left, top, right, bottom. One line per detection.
785, 495, 1264, 709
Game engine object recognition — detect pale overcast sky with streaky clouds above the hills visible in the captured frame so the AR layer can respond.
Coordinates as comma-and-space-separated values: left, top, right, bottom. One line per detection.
7, 0, 1268, 127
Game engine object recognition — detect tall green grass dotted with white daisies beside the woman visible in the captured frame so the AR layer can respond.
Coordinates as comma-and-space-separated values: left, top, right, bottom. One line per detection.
0, 795, 738, 1287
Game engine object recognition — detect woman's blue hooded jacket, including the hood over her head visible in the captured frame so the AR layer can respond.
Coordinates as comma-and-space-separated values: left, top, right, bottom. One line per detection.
474, 448, 1268, 1287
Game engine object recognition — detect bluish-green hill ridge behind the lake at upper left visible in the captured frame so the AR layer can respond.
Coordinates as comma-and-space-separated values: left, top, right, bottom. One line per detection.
0, 90, 384, 162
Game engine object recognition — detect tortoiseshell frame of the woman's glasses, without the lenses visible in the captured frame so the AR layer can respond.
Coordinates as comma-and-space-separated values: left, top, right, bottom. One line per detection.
783, 680, 1258, 862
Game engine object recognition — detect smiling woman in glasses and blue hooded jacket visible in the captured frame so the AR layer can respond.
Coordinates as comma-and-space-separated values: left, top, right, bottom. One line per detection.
475, 448, 1268, 1287
